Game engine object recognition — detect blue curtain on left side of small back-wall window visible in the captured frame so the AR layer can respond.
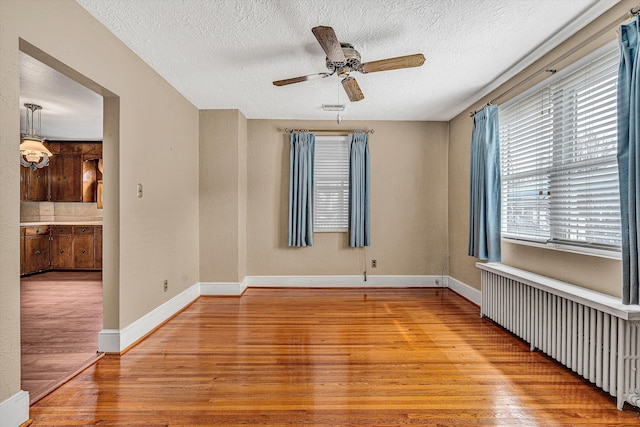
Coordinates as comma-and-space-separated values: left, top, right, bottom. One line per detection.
289, 132, 316, 247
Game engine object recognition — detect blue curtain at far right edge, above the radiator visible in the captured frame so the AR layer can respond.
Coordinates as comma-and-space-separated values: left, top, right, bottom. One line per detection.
618, 17, 640, 304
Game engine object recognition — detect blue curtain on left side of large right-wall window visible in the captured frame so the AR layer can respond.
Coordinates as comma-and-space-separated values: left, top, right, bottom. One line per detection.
468, 105, 502, 262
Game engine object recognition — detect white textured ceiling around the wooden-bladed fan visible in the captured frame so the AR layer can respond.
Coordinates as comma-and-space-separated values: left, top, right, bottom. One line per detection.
21, 0, 618, 139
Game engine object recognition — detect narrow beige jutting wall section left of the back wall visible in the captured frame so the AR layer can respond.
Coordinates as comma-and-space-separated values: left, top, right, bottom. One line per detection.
199, 110, 247, 283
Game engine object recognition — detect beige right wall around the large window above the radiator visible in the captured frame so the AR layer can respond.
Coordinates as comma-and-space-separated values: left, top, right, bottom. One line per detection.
449, 0, 637, 297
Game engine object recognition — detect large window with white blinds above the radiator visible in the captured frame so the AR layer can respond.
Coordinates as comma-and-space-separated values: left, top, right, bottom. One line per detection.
500, 50, 621, 251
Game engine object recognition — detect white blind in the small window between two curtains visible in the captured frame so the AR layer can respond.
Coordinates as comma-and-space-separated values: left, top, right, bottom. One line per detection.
313, 136, 349, 232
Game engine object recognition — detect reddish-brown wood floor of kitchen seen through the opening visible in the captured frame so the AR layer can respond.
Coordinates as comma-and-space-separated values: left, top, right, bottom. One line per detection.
20, 271, 102, 403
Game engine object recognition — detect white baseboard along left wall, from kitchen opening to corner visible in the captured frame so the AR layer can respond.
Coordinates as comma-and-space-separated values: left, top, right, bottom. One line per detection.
98, 284, 200, 353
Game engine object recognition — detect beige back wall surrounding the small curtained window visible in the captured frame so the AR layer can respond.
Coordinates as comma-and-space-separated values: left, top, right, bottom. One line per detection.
247, 120, 448, 276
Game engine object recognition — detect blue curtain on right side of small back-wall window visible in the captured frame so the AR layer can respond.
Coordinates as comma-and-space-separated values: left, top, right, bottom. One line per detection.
349, 133, 371, 248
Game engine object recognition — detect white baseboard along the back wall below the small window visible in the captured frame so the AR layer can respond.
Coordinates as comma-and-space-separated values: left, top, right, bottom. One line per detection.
247, 275, 446, 288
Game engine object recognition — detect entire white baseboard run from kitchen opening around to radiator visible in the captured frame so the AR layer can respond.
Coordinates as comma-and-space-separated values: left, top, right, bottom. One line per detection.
98, 275, 481, 353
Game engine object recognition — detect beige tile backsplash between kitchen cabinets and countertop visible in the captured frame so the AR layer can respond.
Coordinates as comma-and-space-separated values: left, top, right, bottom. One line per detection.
20, 202, 102, 222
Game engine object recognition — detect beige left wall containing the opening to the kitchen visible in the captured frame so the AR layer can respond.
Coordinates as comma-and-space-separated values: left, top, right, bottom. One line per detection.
0, 0, 198, 402
